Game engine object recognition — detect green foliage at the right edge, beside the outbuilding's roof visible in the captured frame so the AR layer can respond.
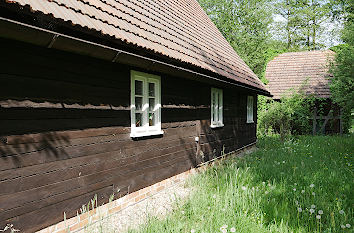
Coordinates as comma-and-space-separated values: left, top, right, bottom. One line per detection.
331, 1, 354, 131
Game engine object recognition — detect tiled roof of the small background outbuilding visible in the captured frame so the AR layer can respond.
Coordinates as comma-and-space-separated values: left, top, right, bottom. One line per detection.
266, 50, 334, 99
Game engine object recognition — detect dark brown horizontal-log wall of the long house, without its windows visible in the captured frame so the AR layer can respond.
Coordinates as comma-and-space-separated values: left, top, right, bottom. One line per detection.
0, 40, 256, 232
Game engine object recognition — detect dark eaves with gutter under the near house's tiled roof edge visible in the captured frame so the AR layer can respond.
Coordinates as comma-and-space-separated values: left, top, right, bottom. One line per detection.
0, 17, 272, 97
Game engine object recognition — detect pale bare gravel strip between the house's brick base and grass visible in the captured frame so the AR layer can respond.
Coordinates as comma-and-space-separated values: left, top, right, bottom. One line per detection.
79, 181, 191, 233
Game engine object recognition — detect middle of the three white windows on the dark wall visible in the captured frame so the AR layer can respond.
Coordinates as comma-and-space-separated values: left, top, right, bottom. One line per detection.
210, 88, 224, 128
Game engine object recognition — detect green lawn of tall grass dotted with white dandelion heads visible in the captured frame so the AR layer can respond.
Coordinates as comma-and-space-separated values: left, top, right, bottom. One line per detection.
130, 135, 354, 233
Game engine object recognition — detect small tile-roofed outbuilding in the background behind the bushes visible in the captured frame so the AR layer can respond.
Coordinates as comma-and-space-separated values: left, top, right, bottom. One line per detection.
266, 50, 342, 134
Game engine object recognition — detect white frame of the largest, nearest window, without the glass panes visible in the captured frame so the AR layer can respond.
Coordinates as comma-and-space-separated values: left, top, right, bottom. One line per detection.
130, 70, 163, 138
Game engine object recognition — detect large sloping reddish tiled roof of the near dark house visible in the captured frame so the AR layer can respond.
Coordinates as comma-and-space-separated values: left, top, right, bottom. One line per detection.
5, 0, 266, 90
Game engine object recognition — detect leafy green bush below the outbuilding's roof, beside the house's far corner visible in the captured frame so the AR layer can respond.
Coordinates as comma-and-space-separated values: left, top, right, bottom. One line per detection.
258, 92, 315, 138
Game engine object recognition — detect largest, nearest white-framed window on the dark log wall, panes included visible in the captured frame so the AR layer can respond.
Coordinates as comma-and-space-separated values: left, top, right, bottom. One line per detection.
130, 71, 163, 137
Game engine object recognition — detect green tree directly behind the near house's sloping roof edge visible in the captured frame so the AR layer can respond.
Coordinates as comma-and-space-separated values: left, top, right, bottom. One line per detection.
199, 0, 272, 77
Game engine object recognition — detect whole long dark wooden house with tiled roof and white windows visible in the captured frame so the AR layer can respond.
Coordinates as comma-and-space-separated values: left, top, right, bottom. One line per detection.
0, 0, 270, 232
